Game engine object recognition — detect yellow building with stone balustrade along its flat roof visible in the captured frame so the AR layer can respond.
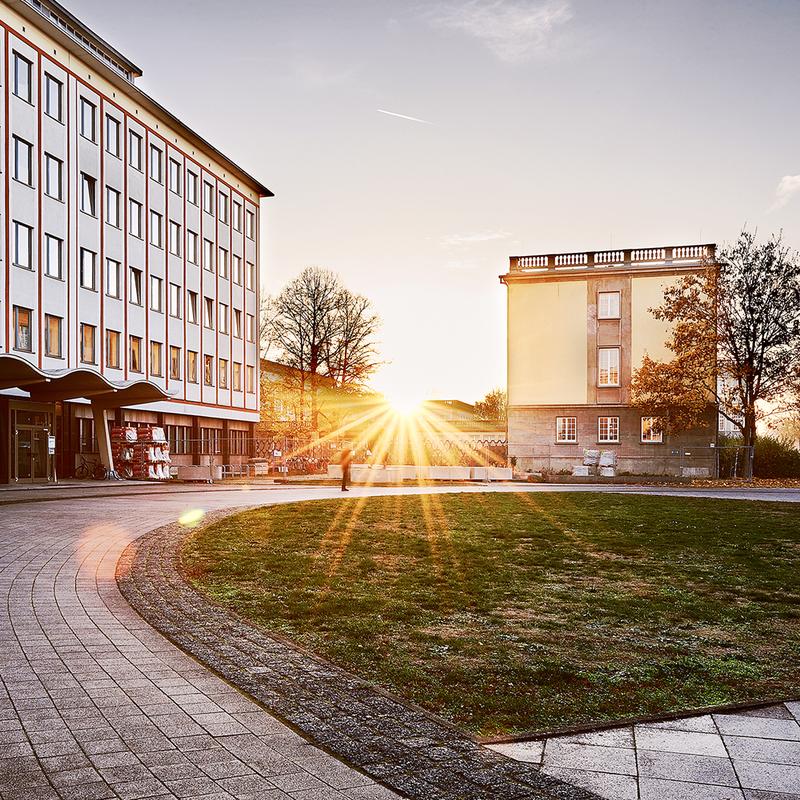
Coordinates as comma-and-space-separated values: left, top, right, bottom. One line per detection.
500, 244, 716, 475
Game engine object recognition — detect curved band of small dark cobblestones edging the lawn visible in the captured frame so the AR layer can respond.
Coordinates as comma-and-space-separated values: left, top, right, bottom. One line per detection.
117, 508, 598, 800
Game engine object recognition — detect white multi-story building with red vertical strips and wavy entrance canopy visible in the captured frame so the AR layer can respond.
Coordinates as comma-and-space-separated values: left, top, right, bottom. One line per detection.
0, 0, 271, 481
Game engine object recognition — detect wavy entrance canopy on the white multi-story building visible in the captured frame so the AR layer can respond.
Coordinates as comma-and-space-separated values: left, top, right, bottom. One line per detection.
0, 353, 171, 408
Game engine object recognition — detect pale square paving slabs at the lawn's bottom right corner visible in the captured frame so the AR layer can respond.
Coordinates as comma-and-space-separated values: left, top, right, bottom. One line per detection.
491, 703, 800, 800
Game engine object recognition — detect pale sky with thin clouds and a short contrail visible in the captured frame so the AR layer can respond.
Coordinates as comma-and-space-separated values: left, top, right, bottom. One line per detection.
63, 0, 800, 402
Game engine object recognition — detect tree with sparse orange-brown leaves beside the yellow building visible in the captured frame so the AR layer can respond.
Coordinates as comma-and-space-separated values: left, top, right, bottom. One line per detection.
631, 231, 800, 476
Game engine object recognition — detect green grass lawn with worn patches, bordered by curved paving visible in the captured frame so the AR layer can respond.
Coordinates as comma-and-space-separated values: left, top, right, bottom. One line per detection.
183, 493, 800, 736
